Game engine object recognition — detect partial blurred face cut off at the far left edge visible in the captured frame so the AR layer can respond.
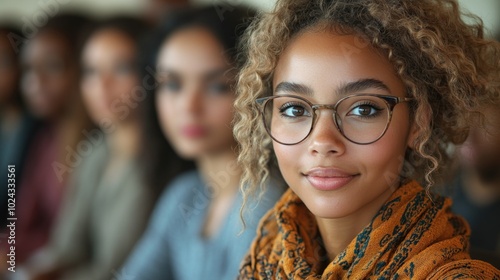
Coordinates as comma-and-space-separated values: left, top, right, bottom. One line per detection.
0, 32, 19, 104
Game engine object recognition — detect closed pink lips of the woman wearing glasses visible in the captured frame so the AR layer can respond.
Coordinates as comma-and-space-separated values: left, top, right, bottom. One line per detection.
304, 167, 359, 191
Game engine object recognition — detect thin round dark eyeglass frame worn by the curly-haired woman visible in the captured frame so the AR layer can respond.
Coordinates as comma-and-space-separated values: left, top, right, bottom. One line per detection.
255, 93, 414, 146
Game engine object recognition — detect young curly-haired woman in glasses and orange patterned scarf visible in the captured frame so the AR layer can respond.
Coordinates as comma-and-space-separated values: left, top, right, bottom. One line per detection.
235, 0, 500, 279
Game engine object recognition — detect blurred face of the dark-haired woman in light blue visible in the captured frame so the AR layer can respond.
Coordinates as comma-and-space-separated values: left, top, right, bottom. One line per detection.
156, 28, 235, 159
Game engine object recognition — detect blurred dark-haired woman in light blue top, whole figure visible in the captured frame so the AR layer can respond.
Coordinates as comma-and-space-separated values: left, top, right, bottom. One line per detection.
119, 7, 283, 280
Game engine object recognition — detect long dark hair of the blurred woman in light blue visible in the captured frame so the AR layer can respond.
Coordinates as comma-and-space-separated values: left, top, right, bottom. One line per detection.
141, 7, 253, 192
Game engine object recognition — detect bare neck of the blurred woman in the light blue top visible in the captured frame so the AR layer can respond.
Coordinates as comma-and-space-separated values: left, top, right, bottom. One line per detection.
196, 148, 242, 196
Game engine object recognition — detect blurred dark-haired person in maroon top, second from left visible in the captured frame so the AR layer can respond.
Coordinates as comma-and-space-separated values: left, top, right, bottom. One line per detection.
7, 14, 88, 265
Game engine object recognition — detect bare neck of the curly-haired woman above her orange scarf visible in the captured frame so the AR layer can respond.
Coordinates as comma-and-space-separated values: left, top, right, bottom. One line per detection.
316, 184, 394, 261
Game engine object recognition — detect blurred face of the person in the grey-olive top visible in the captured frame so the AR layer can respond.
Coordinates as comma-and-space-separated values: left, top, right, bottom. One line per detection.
81, 29, 139, 124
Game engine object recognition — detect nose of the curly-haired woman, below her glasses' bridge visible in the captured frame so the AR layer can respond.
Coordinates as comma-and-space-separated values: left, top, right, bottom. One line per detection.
309, 110, 345, 156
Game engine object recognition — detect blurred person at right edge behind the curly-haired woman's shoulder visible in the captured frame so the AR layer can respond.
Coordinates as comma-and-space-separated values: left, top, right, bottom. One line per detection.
447, 104, 500, 268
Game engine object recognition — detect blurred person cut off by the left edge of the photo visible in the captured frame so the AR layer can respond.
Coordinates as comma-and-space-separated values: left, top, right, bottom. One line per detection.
0, 25, 35, 229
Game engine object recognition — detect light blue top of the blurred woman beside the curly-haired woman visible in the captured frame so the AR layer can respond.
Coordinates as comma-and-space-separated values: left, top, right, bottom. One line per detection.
120, 171, 284, 280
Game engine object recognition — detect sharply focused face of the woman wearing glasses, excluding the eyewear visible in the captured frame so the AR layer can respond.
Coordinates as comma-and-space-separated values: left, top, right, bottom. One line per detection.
273, 30, 414, 219
